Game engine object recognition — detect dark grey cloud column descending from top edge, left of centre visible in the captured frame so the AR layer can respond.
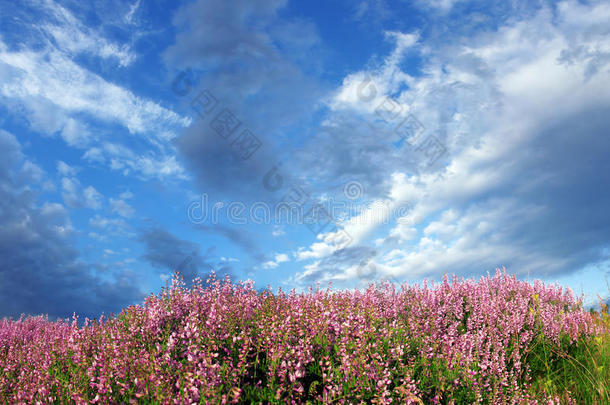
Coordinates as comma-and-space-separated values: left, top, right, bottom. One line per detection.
164, 0, 322, 200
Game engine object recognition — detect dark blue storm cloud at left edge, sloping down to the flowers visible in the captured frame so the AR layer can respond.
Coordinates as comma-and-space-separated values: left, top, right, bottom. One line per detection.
0, 130, 143, 318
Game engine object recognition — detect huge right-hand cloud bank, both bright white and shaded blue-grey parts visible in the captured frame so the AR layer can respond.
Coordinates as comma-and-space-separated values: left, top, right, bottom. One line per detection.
288, 2, 610, 288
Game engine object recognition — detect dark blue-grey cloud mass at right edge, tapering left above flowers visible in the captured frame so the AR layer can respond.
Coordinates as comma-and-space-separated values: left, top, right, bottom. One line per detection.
439, 108, 610, 279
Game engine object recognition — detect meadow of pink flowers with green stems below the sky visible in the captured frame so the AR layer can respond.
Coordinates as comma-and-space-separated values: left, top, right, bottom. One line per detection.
0, 270, 610, 404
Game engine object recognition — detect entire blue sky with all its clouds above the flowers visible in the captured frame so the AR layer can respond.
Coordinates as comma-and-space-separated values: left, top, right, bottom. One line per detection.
0, 0, 610, 317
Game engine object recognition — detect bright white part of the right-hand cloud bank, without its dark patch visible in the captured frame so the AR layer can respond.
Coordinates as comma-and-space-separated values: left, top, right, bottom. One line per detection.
295, 1, 610, 288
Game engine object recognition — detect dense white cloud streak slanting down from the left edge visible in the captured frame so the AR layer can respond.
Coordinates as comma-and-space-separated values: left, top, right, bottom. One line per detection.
0, 45, 190, 135
